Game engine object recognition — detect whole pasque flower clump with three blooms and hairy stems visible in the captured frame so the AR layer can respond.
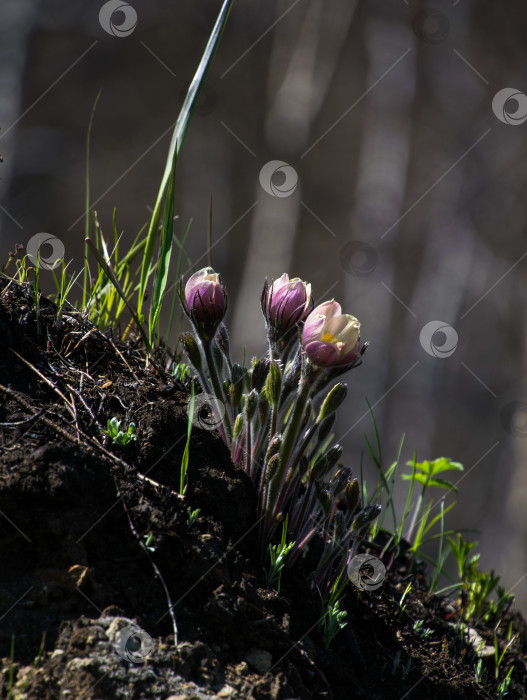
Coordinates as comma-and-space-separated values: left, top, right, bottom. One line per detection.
180, 268, 380, 598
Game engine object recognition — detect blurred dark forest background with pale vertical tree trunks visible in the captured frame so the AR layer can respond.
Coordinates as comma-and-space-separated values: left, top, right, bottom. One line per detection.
0, 0, 527, 612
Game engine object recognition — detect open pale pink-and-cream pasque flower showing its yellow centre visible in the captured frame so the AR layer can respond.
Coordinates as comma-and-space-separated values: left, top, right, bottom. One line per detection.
302, 300, 360, 367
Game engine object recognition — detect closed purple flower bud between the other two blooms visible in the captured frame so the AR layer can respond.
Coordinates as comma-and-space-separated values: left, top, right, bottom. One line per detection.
262, 273, 313, 333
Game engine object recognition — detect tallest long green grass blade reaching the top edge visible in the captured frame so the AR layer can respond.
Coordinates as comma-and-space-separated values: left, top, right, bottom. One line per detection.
137, 0, 233, 317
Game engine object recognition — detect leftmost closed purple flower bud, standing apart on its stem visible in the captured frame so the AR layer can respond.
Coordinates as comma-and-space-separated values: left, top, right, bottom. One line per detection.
185, 267, 227, 337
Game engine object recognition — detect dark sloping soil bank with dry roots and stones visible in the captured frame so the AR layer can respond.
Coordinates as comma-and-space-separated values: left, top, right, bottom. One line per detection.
0, 279, 527, 700
